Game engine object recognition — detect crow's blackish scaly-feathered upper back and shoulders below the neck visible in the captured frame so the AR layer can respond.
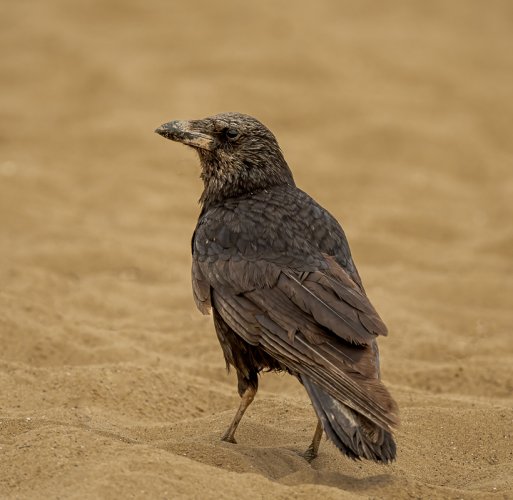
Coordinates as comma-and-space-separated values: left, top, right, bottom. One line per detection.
192, 186, 353, 270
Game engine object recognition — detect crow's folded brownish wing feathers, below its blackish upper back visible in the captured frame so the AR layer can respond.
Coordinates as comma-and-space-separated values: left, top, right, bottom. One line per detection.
193, 255, 397, 428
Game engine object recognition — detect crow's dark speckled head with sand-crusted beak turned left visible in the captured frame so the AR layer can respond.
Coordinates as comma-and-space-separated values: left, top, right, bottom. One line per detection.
155, 113, 294, 204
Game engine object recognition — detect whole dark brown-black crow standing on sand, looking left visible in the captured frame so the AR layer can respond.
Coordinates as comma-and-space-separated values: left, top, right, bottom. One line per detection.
155, 112, 399, 463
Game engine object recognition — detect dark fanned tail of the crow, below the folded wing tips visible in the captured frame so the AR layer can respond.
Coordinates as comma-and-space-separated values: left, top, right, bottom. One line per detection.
301, 375, 396, 463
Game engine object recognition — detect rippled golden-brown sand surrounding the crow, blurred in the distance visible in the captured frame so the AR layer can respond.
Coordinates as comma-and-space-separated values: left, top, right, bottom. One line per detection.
0, 0, 513, 499
